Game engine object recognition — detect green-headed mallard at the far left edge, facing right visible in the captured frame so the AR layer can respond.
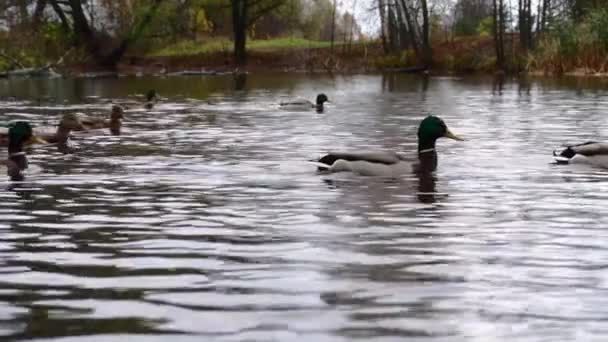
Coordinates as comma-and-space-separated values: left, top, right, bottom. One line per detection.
6, 121, 46, 181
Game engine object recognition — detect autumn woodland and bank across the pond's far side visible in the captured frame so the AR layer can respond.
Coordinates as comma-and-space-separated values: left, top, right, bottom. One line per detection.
0, 0, 608, 75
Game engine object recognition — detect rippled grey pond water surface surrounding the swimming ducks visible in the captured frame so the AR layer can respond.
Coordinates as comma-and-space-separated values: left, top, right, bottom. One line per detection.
0, 75, 608, 342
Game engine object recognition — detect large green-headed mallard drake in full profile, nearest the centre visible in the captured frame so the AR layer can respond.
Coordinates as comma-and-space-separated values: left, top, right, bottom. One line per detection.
317, 115, 464, 177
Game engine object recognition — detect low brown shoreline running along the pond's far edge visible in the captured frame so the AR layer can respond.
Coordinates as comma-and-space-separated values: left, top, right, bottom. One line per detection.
0, 55, 608, 80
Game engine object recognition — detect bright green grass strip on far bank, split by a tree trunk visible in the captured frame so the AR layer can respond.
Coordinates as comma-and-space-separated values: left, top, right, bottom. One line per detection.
148, 38, 339, 57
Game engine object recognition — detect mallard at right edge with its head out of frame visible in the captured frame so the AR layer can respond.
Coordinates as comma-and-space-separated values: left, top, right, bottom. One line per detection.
553, 141, 608, 168
